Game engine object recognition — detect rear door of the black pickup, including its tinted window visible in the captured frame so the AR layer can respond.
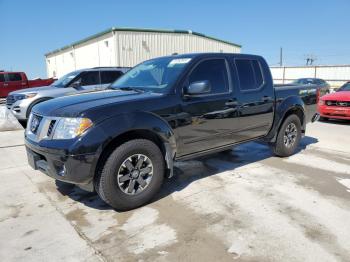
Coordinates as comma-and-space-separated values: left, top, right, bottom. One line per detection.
232, 58, 275, 140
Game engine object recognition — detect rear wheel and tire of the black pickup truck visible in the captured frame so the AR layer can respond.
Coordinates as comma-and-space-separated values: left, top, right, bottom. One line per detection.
273, 115, 301, 157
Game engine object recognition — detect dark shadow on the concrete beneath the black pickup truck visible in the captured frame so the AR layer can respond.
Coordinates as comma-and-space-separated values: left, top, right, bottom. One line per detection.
56, 136, 318, 210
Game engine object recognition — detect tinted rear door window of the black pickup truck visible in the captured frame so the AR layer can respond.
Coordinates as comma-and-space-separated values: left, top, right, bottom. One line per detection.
235, 59, 264, 91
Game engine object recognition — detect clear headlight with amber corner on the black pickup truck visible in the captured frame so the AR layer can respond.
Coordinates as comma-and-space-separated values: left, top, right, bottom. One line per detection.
52, 118, 92, 139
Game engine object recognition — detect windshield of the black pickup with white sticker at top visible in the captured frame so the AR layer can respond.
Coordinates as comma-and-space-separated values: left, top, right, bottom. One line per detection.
110, 57, 191, 93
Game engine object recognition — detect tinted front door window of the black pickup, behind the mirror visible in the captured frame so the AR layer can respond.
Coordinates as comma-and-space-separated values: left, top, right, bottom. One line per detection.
189, 59, 229, 94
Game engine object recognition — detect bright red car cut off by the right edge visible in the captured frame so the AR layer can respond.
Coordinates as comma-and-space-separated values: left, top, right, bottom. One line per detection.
317, 82, 350, 120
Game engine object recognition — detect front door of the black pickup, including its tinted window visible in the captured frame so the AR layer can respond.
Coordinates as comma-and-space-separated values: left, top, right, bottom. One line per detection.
175, 57, 238, 156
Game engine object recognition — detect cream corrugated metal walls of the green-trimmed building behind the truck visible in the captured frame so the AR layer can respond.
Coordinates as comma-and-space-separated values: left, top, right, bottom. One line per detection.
46, 31, 240, 77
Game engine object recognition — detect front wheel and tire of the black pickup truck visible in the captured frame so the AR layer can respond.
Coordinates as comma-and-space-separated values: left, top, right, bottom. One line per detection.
95, 139, 165, 211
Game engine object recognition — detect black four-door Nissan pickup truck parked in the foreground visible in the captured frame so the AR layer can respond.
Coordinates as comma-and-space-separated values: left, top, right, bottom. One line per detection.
25, 53, 320, 210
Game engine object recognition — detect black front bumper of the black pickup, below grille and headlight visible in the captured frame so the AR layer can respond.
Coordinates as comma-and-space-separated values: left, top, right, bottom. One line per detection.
25, 139, 96, 191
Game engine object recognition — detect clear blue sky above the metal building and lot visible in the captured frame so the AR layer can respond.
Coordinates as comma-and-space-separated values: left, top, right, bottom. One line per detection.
0, 0, 350, 77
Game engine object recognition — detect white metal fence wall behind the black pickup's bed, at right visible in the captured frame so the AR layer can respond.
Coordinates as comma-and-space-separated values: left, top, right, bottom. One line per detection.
271, 65, 350, 88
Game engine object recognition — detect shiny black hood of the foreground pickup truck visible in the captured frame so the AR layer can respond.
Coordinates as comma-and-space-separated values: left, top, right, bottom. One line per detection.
33, 89, 162, 117
